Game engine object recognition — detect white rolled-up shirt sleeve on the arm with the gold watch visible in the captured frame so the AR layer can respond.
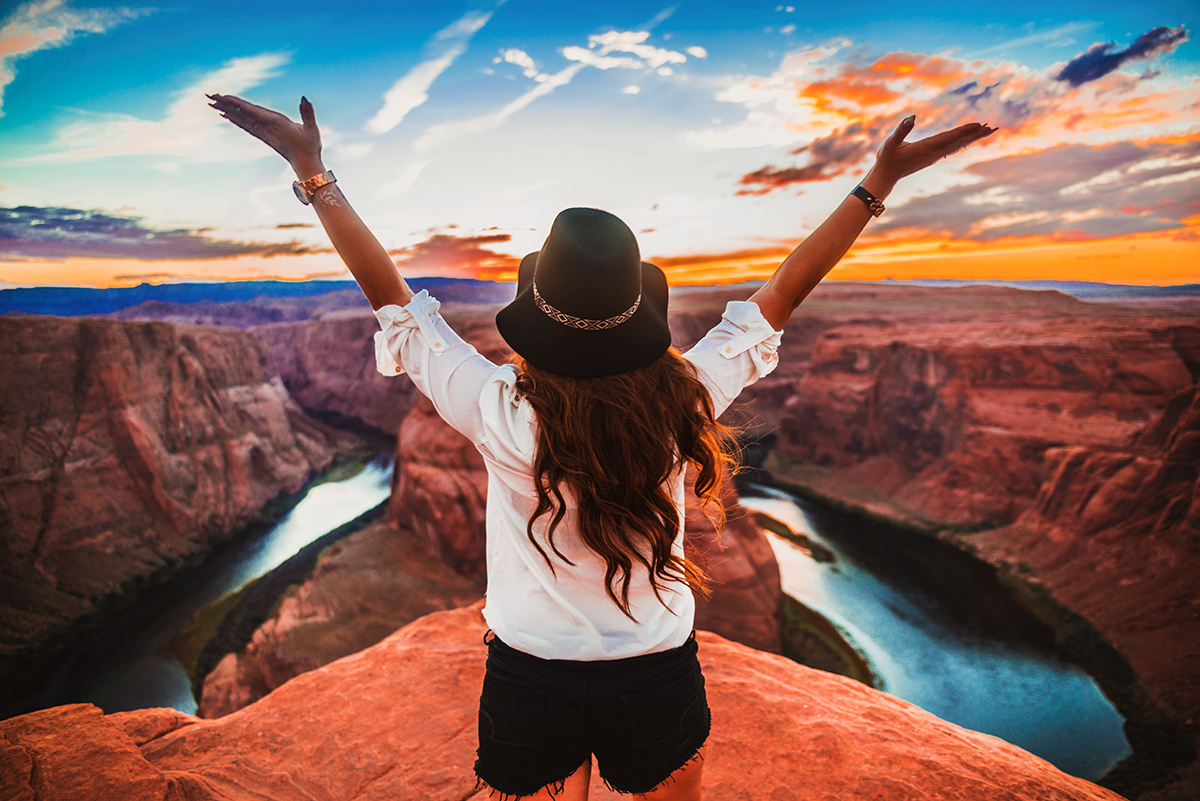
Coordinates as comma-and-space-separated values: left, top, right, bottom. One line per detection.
374, 290, 498, 445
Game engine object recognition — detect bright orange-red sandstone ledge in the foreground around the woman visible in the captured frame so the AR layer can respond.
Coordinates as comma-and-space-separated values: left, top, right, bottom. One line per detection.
0, 604, 1121, 801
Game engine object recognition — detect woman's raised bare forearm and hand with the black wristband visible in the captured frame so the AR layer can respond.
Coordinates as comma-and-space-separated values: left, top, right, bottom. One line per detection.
750, 116, 996, 331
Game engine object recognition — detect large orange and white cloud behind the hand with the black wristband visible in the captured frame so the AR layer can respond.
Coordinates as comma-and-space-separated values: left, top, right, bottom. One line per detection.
727, 28, 1200, 205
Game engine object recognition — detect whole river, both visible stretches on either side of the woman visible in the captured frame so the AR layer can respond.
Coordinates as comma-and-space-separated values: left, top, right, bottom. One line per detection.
30, 456, 1130, 779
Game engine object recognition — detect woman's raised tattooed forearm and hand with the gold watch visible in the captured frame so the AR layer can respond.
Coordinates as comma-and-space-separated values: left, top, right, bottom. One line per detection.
208, 95, 413, 308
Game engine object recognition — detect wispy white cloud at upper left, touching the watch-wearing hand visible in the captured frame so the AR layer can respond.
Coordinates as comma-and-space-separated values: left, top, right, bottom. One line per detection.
19, 53, 289, 164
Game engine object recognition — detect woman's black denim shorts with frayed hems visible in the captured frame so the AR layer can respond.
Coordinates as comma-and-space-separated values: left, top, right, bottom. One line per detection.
475, 633, 712, 797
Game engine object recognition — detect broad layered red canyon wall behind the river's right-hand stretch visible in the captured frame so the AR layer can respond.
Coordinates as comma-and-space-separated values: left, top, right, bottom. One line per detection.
768, 287, 1196, 530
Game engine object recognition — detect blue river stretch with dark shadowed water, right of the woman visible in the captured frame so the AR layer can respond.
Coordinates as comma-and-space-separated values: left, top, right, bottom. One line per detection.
742, 487, 1132, 779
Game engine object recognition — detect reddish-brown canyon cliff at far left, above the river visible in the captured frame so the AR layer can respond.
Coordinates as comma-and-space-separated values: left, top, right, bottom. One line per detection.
0, 318, 334, 705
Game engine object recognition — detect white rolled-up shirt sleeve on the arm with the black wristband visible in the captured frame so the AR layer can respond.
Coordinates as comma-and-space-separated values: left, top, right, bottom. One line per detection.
684, 301, 782, 415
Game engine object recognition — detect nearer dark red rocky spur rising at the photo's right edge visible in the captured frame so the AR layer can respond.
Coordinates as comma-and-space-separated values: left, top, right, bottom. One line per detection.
962, 386, 1200, 797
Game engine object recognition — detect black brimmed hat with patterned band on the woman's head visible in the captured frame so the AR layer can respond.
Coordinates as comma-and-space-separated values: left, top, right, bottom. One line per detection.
496, 209, 671, 378
